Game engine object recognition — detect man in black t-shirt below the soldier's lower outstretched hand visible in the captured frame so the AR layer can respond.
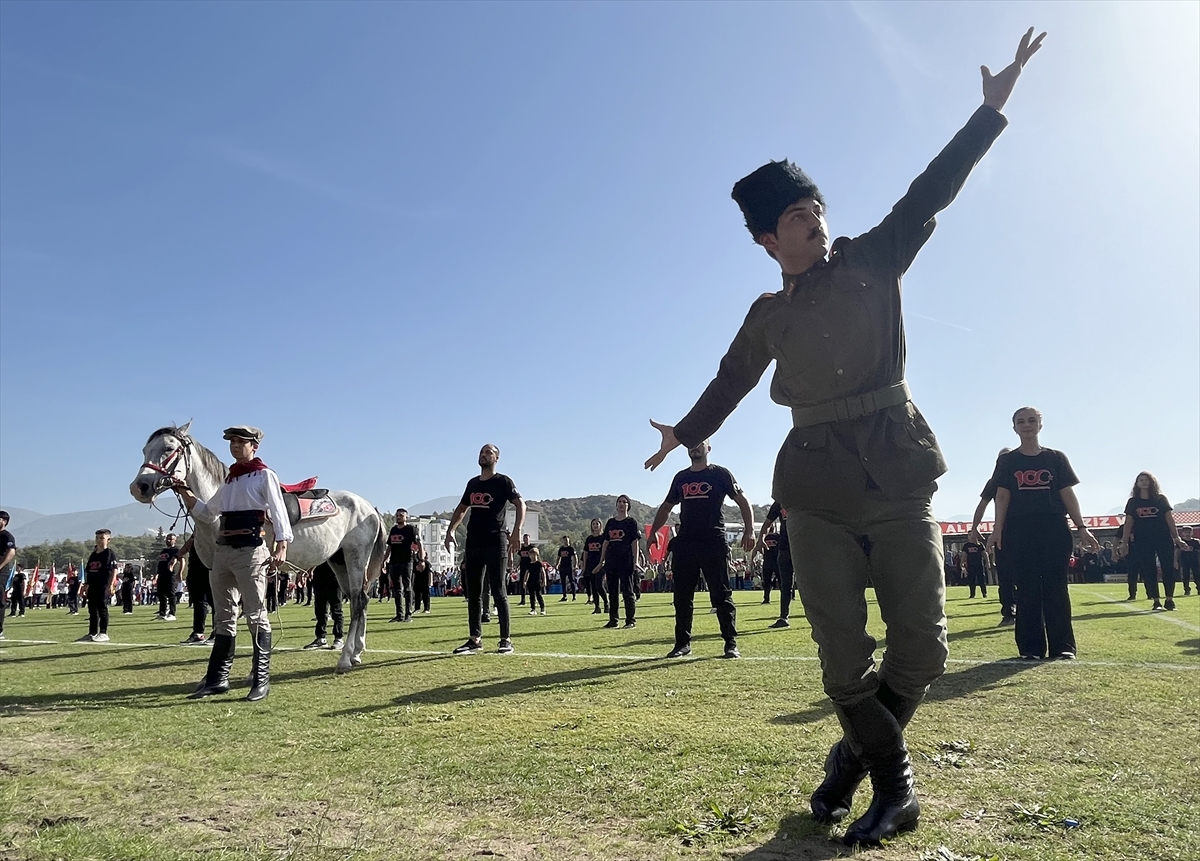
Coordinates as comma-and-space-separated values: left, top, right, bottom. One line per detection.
649, 440, 755, 658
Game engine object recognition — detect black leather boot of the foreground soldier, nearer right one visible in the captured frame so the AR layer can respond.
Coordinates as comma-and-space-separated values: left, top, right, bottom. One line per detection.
839, 697, 920, 845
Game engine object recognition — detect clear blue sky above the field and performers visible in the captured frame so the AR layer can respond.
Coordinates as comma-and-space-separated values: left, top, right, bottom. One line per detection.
0, 0, 1200, 518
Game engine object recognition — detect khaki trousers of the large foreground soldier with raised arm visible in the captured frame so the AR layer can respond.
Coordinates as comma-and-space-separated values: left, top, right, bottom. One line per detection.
787, 484, 949, 705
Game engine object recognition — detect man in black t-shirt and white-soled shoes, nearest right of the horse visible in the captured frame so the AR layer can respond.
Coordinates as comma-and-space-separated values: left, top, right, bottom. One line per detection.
445, 442, 526, 655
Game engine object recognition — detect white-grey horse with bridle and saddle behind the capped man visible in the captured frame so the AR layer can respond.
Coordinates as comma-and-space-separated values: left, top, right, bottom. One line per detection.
130, 422, 388, 673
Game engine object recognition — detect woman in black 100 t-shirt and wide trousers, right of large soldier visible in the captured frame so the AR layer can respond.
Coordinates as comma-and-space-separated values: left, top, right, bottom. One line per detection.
988, 407, 1099, 660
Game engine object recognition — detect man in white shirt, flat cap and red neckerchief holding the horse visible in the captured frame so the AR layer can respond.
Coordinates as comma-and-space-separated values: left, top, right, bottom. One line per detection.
174, 425, 292, 703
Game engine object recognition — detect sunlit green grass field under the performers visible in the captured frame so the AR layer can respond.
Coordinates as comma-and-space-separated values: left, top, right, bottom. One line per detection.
0, 585, 1200, 861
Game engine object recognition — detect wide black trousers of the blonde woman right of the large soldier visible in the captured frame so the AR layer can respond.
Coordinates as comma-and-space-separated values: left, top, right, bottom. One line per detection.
1003, 514, 1076, 657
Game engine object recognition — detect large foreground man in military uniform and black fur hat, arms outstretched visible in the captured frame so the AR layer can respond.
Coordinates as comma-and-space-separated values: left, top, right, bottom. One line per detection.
646, 29, 1044, 844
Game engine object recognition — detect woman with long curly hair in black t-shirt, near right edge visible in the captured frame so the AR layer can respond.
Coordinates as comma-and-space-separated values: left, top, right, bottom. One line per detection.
1117, 472, 1186, 610
